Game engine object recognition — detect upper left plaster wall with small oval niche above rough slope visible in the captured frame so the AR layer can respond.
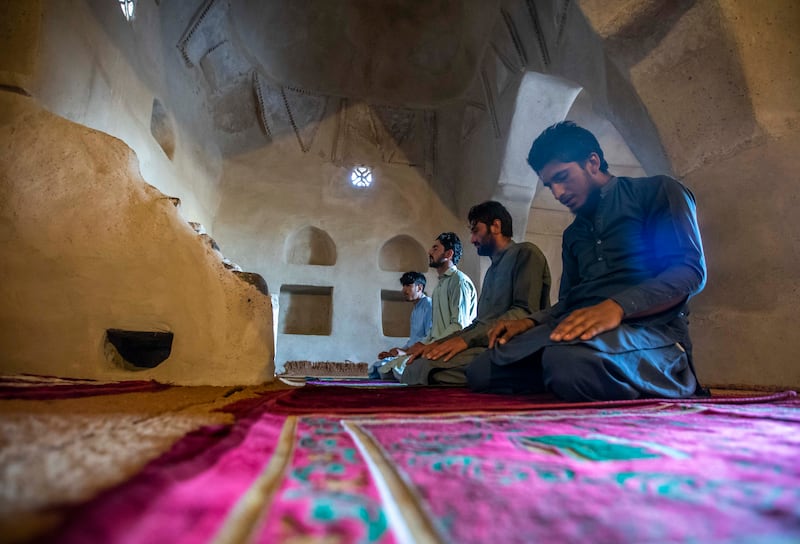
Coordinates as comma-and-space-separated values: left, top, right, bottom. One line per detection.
23, 0, 221, 228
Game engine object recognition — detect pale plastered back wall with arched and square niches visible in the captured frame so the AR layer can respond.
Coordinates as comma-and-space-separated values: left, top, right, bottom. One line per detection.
209, 111, 477, 372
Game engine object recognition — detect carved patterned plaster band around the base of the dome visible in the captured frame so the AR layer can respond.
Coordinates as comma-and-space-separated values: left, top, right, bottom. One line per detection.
177, 0, 572, 163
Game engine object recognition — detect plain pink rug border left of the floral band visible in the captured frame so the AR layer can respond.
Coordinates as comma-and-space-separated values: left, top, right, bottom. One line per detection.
49, 412, 291, 544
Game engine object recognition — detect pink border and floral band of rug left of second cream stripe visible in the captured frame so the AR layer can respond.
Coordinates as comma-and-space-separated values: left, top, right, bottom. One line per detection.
44, 411, 396, 544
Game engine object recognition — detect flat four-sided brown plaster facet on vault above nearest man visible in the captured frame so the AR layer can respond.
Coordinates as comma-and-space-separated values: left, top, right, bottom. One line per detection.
631, 0, 759, 175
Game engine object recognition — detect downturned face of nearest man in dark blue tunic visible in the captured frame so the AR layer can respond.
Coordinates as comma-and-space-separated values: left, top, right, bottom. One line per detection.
539, 156, 600, 213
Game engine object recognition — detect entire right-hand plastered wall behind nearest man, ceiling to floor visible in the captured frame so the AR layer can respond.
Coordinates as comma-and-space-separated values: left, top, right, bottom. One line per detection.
600, 0, 800, 387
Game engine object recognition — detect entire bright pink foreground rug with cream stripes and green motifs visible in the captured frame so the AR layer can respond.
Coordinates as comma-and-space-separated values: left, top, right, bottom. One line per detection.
47, 388, 800, 544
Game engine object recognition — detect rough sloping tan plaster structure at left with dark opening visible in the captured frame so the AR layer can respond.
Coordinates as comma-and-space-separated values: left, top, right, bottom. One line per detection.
0, 92, 273, 385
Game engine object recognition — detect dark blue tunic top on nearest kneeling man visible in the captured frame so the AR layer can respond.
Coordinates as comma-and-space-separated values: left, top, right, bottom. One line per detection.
531, 176, 706, 324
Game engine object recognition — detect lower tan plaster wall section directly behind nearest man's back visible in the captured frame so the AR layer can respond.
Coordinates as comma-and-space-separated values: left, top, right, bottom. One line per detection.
686, 132, 800, 387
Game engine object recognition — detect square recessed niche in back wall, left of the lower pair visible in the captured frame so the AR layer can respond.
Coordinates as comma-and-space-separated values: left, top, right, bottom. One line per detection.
278, 285, 333, 336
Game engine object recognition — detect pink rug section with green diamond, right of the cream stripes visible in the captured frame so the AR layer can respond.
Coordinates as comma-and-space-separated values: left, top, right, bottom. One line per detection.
344, 401, 800, 543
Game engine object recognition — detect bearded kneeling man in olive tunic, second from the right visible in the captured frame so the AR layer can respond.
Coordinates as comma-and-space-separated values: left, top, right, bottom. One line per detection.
401, 201, 550, 386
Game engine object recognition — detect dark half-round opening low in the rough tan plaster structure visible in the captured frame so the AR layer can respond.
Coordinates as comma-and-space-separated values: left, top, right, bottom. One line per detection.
105, 329, 173, 370
